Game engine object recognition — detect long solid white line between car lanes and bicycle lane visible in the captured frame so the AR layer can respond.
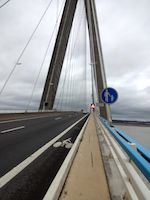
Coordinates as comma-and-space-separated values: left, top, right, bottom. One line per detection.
0, 115, 87, 188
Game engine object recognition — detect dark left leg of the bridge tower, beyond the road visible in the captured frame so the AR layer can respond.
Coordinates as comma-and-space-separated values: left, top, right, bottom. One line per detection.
39, 0, 78, 110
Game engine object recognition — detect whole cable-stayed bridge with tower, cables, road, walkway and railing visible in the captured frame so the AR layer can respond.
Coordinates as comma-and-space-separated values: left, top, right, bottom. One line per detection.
0, 0, 150, 200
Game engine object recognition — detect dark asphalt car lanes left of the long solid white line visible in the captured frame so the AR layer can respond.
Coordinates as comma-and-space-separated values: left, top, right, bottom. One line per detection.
0, 113, 83, 177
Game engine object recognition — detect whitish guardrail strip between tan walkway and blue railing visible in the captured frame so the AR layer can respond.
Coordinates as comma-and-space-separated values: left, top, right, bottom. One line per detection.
97, 117, 150, 200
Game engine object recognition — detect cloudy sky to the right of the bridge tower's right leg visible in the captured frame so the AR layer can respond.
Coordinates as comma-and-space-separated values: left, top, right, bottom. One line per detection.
97, 0, 150, 121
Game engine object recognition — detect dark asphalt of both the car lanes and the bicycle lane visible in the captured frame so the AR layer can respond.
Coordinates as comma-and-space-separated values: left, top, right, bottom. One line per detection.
0, 113, 87, 200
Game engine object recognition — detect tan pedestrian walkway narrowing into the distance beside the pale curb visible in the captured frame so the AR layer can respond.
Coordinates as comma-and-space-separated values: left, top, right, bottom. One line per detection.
59, 115, 110, 200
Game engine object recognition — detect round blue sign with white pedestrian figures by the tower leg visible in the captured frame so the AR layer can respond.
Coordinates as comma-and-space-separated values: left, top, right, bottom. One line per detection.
101, 87, 118, 104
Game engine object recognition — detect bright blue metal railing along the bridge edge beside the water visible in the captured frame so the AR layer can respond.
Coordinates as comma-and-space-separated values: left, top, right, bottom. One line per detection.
100, 118, 150, 181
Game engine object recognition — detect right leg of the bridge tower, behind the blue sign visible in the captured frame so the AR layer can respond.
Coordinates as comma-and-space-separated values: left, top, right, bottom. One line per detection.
84, 0, 111, 122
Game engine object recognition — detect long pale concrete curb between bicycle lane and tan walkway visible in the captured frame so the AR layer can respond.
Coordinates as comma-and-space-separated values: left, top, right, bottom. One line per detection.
43, 117, 89, 200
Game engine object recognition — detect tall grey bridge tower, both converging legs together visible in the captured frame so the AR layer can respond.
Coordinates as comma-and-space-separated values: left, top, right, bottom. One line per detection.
39, 0, 111, 121
